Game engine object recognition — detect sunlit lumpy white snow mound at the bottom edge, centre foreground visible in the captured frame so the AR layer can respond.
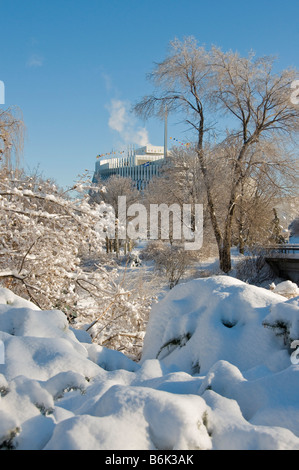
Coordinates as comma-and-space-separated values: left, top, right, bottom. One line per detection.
45, 385, 212, 450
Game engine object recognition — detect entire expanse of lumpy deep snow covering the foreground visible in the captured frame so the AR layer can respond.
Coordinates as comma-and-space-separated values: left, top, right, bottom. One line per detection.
0, 276, 299, 450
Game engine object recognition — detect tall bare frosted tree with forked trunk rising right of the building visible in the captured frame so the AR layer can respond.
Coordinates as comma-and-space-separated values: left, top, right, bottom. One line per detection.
135, 38, 299, 272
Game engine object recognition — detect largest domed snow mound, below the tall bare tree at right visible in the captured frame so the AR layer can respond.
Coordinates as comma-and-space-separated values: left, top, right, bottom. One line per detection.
143, 276, 288, 374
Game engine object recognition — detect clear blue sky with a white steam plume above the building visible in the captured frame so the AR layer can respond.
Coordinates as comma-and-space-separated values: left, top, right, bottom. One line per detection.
0, 0, 299, 186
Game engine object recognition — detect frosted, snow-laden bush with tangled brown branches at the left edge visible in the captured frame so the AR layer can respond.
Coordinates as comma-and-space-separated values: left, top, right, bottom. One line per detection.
0, 170, 154, 355
